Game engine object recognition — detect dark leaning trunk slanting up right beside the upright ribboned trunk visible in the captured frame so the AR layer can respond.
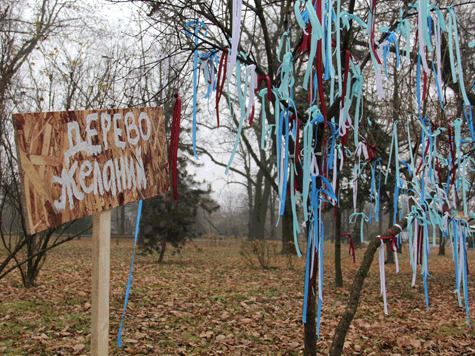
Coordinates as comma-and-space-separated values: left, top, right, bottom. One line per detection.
330, 218, 407, 356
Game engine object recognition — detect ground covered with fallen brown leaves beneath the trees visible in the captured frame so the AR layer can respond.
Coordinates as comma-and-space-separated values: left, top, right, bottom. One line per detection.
0, 239, 475, 355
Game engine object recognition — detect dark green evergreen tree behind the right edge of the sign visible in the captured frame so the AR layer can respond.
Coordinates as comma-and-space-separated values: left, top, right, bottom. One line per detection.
140, 158, 218, 263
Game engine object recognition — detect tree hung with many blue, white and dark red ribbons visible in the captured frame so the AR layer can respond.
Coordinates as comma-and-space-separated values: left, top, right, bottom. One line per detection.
127, 0, 473, 354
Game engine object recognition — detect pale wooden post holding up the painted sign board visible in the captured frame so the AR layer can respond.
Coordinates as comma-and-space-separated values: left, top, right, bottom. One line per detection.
91, 210, 111, 356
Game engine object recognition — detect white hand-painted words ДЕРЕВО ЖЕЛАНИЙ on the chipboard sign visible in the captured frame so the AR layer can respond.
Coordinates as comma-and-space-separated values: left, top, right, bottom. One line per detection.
53, 111, 153, 212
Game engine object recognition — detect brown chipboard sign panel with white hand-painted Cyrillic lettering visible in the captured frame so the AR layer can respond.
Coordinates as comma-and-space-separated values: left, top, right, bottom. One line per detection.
13, 108, 168, 234
